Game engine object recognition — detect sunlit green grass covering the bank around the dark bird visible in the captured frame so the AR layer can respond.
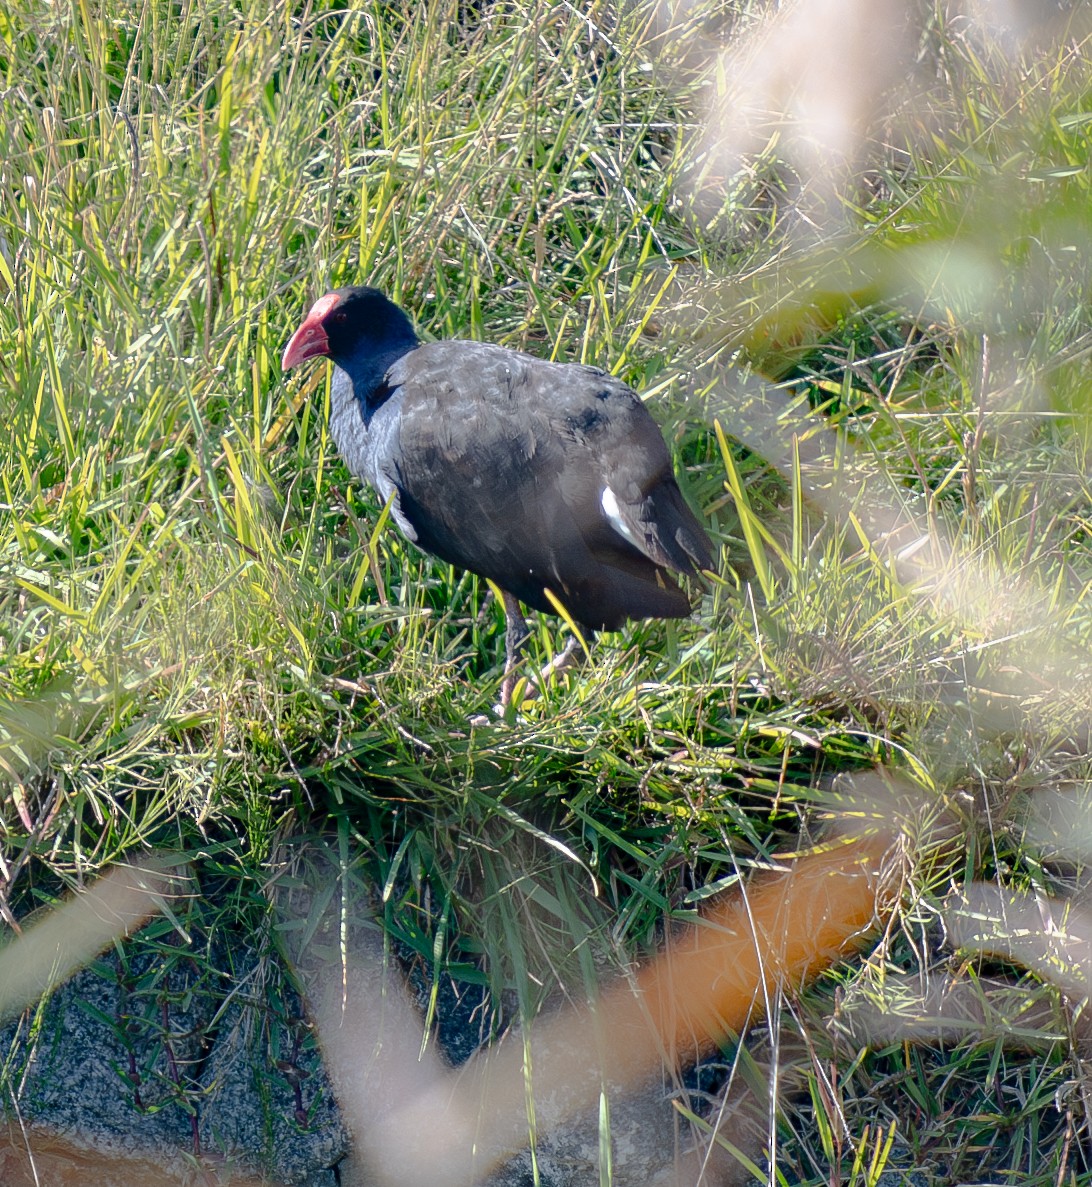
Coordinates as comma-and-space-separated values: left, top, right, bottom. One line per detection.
0, 0, 1092, 1182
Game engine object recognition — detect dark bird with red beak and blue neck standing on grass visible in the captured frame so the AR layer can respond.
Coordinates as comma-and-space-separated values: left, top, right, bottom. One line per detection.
281, 285, 713, 709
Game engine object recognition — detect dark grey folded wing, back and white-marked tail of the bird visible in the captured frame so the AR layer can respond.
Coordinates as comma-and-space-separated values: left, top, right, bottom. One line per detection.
372, 342, 711, 627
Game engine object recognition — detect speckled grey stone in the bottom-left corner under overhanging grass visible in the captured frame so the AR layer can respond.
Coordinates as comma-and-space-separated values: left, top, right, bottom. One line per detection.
0, 946, 347, 1187
